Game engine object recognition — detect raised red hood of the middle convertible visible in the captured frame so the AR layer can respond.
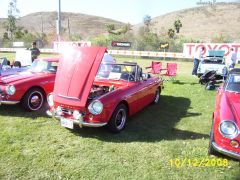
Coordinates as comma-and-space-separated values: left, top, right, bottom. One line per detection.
53, 47, 106, 107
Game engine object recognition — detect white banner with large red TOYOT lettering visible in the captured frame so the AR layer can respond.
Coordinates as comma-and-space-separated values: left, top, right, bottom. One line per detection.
183, 43, 240, 57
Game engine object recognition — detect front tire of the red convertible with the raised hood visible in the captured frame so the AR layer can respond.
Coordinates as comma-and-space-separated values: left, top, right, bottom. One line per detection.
107, 104, 128, 133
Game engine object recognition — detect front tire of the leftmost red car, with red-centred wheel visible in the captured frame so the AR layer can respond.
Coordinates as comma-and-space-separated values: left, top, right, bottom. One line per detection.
21, 88, 45, 111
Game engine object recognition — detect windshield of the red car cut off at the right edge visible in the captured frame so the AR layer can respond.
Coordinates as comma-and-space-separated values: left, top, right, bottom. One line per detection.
225, 74, 240, 93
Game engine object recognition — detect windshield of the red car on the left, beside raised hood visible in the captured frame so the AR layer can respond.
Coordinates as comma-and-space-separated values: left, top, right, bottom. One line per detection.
30, 60, 58, 72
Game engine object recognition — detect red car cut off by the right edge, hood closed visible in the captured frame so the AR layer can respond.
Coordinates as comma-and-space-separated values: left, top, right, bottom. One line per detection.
209, 69, 240, 160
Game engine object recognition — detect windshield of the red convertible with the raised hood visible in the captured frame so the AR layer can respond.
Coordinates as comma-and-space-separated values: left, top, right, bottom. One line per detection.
96, 64, 136, 81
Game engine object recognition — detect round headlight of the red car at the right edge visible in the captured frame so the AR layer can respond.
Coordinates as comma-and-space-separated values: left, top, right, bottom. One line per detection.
219, 121, 238, 139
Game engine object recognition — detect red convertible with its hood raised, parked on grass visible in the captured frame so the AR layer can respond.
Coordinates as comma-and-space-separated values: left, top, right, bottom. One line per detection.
47, 47, 162, 132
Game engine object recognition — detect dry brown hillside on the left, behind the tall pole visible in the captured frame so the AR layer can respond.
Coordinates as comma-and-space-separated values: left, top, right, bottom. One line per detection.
0, 12, 124, 39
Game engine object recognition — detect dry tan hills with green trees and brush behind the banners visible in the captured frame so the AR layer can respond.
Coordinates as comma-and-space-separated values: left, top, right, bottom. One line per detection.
0, 3, 240, 52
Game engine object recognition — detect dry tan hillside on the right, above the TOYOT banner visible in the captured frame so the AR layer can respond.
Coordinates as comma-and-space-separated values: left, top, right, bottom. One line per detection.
134, 3, 240, 42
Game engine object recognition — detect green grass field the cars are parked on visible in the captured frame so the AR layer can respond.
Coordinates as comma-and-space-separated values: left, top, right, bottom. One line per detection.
0, 53, 240, 180
